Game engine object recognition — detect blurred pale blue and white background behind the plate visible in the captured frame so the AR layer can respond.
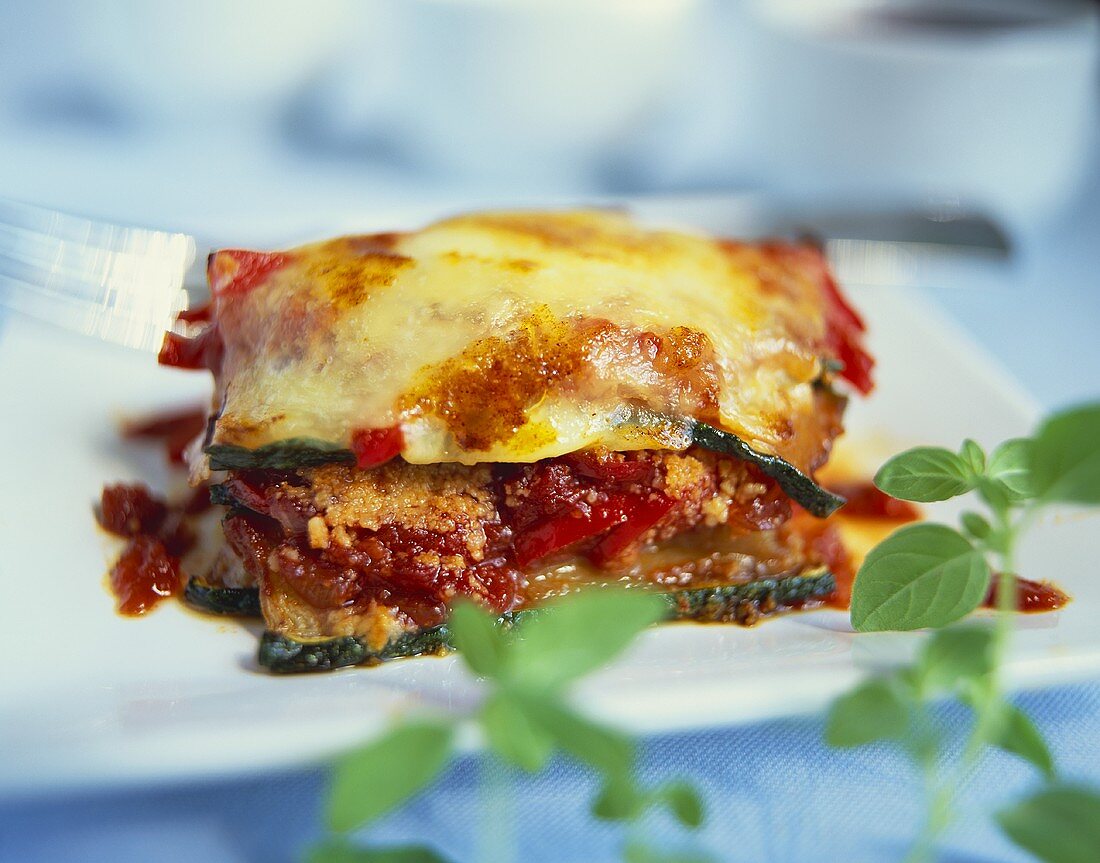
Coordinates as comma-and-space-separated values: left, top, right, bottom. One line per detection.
0, 0, 1100, 240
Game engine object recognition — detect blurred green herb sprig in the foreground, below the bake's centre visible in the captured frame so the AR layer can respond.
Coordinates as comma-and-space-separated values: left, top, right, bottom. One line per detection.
309, 588, 704, 863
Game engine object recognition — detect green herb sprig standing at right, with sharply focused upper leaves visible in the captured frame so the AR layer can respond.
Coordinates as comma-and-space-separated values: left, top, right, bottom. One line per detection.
825, 403, 1100, 863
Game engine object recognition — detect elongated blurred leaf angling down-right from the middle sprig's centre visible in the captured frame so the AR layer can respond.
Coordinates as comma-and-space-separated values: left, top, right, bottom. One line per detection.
512, 689, 635, 777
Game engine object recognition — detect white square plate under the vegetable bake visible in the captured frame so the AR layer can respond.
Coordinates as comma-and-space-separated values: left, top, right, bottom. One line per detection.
0, 200, 1100, 795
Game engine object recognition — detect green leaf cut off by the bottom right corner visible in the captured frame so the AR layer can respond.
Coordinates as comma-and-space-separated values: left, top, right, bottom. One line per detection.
997, 785, 1100, 863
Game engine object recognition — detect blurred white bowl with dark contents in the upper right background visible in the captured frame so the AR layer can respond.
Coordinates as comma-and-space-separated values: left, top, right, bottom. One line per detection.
749, 0, 1100, 223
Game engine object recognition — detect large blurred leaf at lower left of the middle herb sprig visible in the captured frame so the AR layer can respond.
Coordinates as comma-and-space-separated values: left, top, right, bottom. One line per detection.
326, 721, 454, 831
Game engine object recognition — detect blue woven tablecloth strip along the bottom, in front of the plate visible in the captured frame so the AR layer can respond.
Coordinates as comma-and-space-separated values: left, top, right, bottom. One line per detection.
0, 685, 1100, 863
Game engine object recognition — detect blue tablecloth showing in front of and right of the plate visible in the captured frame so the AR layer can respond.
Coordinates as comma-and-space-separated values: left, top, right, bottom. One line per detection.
0, 123, 1100, 863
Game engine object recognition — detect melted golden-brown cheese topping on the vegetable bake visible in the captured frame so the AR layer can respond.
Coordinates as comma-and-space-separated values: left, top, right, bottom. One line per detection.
210, 211, 827, 468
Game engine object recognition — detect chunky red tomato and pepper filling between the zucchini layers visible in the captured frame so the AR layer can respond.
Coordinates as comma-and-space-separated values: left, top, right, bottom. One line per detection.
210, 452, 790, 626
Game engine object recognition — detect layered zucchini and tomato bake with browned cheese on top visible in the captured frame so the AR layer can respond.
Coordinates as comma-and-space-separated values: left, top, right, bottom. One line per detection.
94, 211, 872, 671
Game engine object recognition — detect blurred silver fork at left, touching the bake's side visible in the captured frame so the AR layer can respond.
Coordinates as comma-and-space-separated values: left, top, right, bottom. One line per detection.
0, 198, 196, 351
